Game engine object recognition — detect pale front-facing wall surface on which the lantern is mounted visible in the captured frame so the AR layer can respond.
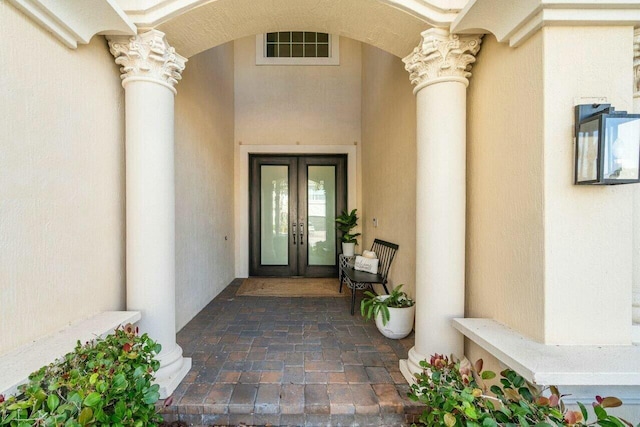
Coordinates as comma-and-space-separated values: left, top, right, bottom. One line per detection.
542, 27, 634, 344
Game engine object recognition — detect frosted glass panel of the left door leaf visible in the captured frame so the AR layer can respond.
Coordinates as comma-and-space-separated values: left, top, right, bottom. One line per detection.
260, 165, 289, 265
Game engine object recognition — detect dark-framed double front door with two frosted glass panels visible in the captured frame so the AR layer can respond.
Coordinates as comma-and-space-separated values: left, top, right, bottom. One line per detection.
249, 155, 347, 277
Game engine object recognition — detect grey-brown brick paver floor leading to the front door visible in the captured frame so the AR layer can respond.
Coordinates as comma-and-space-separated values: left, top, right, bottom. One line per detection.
162, 279, 422, 426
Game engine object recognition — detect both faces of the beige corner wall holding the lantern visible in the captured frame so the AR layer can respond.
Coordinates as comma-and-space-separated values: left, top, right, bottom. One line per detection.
466, 27, 633, 344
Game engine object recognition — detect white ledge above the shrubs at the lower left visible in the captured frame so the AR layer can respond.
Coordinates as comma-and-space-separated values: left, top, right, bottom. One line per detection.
0, 311, 141, 395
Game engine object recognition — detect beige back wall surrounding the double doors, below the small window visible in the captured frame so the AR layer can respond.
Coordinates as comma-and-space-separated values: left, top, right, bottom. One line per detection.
234, 36, 362, 277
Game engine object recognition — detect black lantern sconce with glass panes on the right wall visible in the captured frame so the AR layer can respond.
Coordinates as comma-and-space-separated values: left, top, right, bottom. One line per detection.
574, 104, 640, 185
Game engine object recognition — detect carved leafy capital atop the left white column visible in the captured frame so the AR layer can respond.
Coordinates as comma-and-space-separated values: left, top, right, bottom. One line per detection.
107, 30, 187, 93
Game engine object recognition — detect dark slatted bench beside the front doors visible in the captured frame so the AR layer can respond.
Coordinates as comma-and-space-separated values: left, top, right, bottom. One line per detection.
338, 239, 399, 315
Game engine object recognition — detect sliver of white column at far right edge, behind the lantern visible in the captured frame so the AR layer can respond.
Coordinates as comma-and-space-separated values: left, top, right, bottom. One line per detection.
632, 28, 640, 334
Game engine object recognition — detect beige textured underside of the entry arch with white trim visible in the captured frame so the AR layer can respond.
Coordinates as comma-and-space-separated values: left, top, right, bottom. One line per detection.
136, 0, 466, 58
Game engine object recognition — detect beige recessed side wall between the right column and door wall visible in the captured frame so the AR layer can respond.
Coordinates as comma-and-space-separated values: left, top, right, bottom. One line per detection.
360, 44, 416, 295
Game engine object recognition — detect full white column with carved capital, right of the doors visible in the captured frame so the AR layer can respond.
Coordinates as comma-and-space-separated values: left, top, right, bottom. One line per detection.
400, 28, 481, 381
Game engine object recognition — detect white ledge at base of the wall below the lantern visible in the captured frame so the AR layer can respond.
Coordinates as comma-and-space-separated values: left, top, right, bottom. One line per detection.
453, 319, 640, 386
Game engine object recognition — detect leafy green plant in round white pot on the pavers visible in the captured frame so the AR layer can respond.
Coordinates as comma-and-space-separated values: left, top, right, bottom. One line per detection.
360, 285, 416, 339
